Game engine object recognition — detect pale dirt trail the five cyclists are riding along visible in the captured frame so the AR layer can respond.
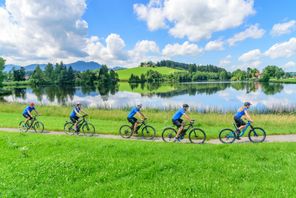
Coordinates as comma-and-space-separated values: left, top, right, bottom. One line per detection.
0, 128, 296, 144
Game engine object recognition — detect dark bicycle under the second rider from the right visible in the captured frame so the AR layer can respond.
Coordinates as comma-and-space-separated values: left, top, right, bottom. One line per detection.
161, 120, 206, 144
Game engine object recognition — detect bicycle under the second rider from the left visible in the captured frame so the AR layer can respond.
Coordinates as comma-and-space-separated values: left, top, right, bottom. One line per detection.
64, 115, 96, 136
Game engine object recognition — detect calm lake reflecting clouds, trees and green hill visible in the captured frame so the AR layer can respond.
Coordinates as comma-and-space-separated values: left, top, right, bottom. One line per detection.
3, 82, 296, 112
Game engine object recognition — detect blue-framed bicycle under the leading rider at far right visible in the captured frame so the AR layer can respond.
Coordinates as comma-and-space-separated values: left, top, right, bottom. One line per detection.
219, 121, 266, 144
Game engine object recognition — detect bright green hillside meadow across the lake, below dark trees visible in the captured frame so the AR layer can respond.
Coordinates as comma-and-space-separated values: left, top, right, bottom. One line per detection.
117, 67, 184, 81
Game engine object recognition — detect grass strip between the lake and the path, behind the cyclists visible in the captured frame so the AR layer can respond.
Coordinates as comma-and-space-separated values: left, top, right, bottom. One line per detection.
0, 103, 296, 138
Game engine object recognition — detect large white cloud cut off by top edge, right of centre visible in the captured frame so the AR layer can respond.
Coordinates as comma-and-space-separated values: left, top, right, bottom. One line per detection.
134, 0, 255, 41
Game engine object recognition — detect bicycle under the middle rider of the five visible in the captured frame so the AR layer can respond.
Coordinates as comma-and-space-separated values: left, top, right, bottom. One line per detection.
119, 119, 156, 140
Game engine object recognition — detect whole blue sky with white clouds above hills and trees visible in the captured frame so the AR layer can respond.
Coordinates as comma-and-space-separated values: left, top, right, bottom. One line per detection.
0, 0, 296, 71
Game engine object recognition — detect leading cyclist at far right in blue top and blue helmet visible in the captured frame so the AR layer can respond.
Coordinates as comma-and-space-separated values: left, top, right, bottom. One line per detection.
233, 102, 253, 139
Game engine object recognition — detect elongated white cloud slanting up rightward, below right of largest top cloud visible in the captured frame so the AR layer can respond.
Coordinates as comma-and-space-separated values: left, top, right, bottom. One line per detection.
227, 24, 265, 46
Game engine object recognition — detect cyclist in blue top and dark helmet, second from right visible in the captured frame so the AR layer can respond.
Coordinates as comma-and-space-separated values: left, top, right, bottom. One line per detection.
172, 104, 192, 142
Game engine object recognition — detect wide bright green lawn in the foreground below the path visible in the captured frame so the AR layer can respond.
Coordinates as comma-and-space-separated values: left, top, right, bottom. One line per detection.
0, 132, 296, 198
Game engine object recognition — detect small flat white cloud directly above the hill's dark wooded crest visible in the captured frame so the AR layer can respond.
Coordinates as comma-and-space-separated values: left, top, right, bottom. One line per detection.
162, 41, 202, 57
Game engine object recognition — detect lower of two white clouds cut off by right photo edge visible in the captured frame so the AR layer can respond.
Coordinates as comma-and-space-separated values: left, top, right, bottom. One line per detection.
265, 37, 296, 59
